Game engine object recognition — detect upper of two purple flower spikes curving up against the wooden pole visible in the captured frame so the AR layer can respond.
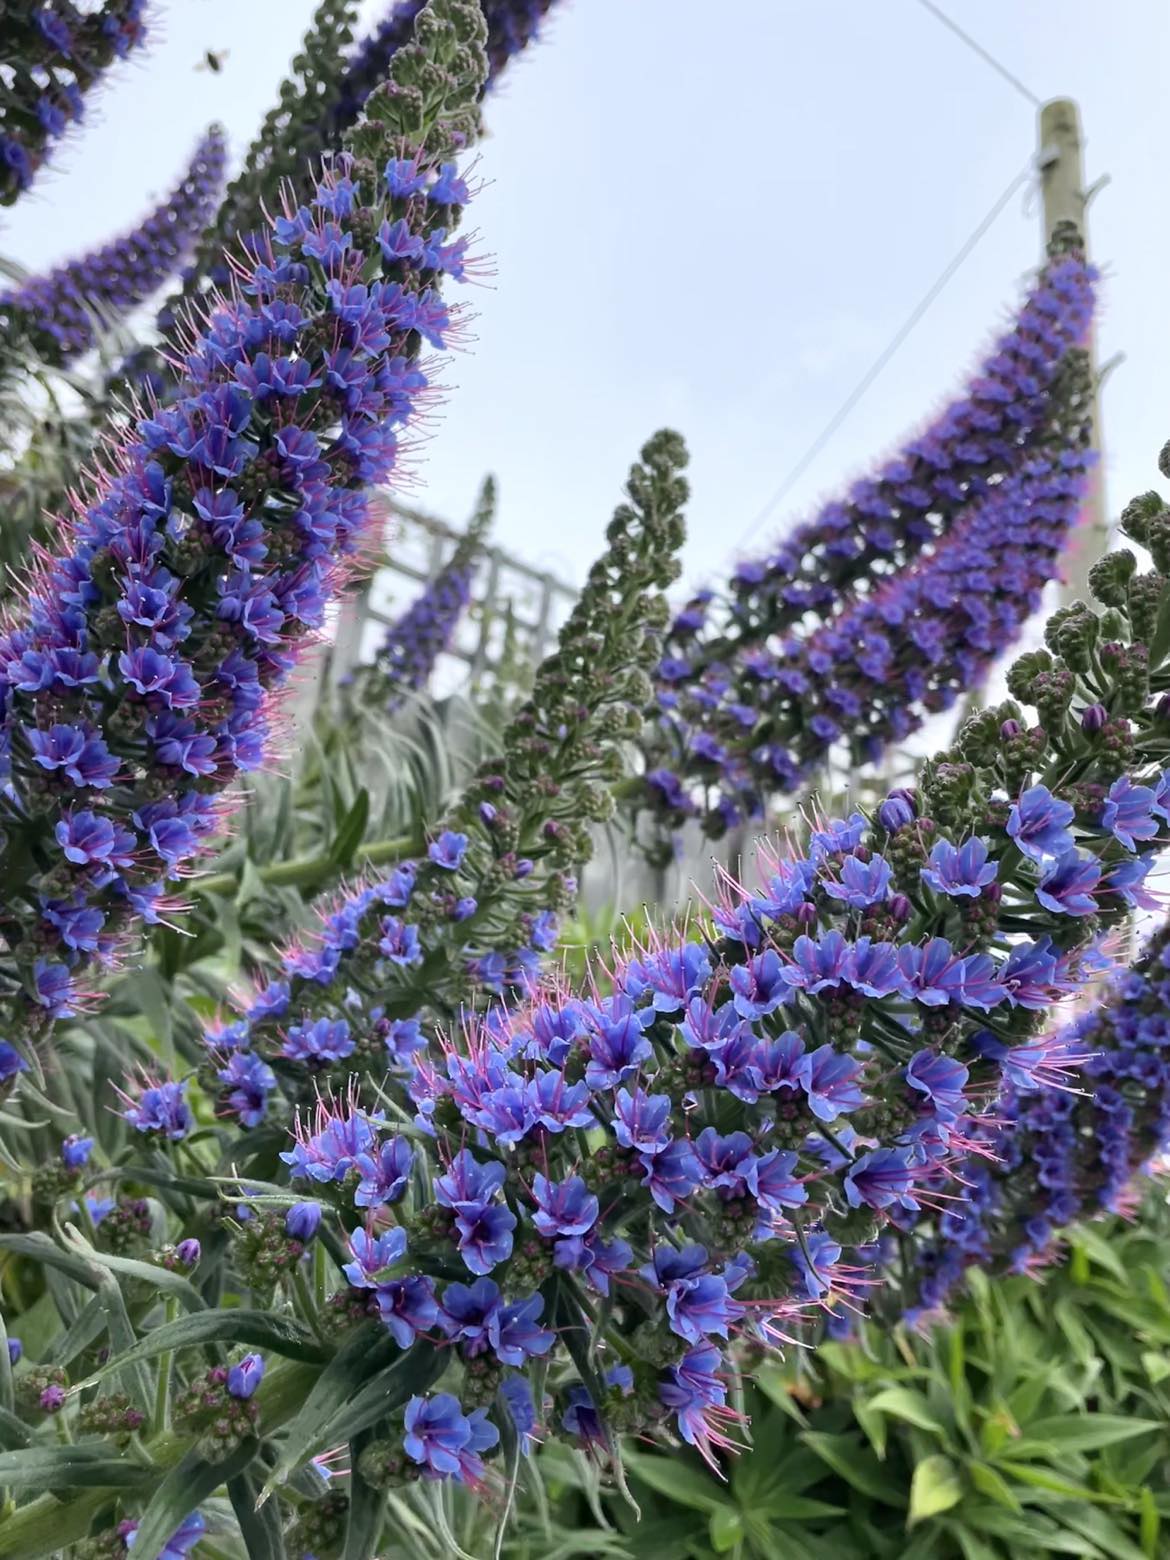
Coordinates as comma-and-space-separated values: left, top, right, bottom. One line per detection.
640, 225, 1095, 835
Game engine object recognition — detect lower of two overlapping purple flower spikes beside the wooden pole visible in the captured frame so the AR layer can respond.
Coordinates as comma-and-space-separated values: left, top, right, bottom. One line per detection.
649, 349, 1095, 833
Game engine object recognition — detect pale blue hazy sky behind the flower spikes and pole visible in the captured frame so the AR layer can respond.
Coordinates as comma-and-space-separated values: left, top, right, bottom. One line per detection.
0, 0, 1170, 580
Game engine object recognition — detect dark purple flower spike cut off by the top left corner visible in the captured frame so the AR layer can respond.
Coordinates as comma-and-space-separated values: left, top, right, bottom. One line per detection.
0, 0, 147, 206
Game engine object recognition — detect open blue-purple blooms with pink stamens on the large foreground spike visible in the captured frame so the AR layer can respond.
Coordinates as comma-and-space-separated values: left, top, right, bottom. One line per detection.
199, 767, 1170, 1487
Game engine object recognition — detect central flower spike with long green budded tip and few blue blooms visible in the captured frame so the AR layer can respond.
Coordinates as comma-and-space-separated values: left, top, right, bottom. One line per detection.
206, 432, 686, 1128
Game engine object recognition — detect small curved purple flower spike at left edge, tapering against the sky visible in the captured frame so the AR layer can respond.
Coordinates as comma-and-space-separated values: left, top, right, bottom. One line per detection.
0, 126, 226, 365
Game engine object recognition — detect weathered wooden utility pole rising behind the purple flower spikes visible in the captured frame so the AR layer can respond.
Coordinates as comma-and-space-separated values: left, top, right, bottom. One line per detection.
1037, 98, 1109, 602
